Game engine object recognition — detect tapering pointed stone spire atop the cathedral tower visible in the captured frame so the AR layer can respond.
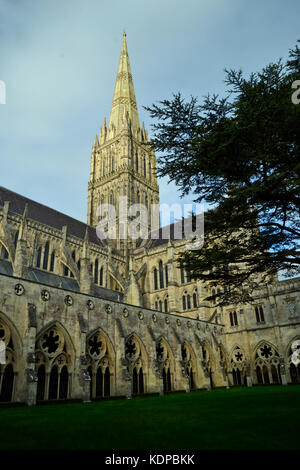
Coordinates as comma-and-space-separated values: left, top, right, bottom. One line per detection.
108, 32, 140, 132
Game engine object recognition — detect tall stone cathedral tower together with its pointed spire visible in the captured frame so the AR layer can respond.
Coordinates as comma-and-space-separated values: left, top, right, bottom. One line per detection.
87, 33, 159, 249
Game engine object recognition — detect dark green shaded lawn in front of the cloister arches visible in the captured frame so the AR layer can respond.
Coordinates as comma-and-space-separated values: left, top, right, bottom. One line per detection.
0, 385, 300, 450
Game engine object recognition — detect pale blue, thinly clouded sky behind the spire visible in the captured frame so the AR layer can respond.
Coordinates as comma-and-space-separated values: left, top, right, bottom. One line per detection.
0, 0, 300, 222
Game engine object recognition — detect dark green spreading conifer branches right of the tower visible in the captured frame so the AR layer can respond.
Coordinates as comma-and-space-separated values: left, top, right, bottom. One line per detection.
145, 40, 300, 305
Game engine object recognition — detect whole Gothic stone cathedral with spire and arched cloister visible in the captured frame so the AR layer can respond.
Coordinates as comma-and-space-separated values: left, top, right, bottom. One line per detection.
0, 33, 300, 405
